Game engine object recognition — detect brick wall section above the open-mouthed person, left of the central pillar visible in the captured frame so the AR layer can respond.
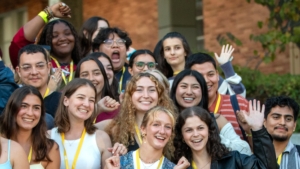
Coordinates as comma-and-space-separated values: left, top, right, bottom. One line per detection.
83, 0, 158, 50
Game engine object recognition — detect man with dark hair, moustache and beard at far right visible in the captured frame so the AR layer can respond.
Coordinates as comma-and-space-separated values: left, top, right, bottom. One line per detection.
264, 96, 300, 169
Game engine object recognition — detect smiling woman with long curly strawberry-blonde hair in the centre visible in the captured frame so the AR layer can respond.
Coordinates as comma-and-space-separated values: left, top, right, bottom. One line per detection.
96, 72, 176, 155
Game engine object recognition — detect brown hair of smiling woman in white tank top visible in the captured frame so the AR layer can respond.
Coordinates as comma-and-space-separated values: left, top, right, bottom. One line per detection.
55, 78, 97, 134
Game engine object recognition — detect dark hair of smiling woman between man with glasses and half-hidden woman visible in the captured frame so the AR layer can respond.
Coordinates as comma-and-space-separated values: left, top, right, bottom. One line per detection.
75, 55, 113, 100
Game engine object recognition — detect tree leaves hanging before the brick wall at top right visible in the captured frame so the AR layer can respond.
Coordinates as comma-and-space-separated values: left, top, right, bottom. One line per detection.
217, 0, 300, 63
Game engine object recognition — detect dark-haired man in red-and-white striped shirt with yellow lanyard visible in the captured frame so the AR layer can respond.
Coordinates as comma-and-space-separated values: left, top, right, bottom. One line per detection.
185, 53, 252, 140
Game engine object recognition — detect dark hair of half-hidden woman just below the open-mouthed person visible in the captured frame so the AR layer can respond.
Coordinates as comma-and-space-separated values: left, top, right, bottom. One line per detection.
88, 52, 119, 101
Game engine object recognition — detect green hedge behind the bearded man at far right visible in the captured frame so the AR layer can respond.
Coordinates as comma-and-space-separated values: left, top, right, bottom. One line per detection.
227, 66, 300, 133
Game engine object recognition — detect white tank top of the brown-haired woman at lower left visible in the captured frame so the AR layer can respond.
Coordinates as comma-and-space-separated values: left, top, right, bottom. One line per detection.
50, 127, 101, 169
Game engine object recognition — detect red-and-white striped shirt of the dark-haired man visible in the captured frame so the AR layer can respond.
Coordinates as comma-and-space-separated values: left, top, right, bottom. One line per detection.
209, 93, 249, 138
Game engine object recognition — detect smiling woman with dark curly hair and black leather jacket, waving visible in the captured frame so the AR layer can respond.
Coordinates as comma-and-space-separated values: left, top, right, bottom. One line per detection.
174, 103, 277, 169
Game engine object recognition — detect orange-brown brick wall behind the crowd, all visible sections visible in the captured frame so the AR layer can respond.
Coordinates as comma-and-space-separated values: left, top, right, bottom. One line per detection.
0, 0, 290, 73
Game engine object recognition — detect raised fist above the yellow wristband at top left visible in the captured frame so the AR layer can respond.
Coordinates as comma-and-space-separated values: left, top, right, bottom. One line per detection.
49, 2, 71, 18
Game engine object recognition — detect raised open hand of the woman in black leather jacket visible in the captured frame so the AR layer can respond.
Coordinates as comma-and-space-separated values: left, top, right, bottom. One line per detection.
241, 99, 265, 131
